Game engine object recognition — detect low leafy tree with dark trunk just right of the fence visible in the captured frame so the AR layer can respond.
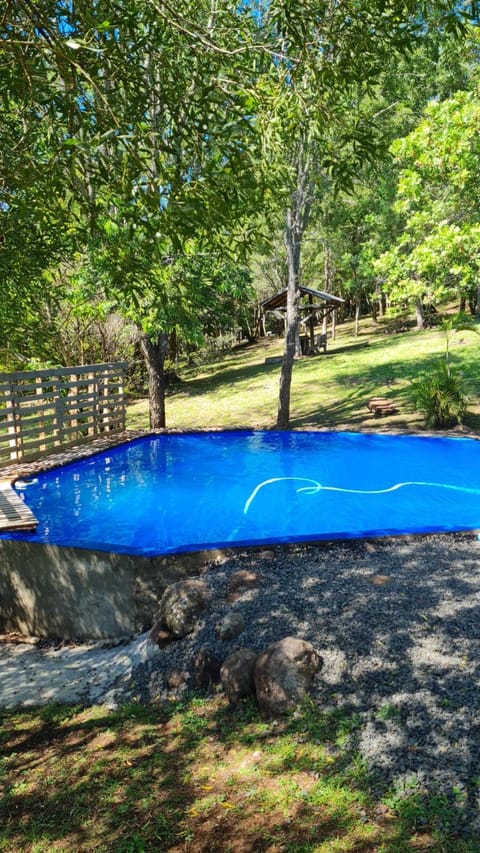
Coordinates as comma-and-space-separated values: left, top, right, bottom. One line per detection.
74, 235, 255, 429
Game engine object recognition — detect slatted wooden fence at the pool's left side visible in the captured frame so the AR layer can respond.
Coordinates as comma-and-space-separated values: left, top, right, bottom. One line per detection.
0, 362, 127, 466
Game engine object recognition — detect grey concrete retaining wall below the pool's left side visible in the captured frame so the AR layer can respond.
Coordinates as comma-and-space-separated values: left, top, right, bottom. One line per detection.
0, 539, 231, 640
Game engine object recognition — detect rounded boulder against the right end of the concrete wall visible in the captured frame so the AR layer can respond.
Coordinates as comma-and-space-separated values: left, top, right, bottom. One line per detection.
159, 578, 209, 637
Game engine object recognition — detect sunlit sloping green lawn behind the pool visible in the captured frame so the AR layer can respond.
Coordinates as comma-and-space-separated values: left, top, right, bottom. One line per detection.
127, 312, 480, 430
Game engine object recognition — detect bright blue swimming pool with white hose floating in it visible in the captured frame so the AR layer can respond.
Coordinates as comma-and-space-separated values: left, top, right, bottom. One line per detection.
2, 430, 480, 557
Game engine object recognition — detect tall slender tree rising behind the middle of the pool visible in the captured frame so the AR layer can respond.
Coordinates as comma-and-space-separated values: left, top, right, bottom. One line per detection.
255, 0, 476, 429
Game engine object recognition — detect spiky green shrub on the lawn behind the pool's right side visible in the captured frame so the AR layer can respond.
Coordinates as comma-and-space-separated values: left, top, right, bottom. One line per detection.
412, 359, 467, 428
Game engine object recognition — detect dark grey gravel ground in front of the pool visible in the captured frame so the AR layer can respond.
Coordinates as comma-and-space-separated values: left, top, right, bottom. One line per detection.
0, 534, 480, 832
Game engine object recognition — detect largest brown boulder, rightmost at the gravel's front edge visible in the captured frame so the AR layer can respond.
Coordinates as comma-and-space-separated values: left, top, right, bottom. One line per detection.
254, 637, 323, 717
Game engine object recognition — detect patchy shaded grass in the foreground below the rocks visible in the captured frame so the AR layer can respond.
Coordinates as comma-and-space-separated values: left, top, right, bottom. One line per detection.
0, 697, 480, 853
